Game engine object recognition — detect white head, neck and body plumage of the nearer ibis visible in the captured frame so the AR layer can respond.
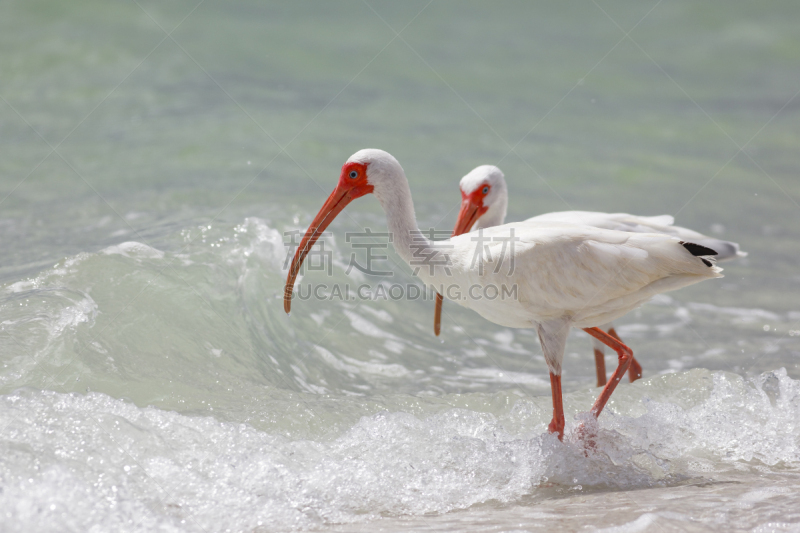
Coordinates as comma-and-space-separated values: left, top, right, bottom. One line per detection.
348, 149, 720, 348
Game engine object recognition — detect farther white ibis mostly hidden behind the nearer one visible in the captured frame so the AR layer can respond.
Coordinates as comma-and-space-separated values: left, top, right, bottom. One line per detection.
433, 165, 747, 387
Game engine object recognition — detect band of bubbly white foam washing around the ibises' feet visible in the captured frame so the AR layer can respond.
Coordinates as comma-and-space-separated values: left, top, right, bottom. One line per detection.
0, 363, 800, 531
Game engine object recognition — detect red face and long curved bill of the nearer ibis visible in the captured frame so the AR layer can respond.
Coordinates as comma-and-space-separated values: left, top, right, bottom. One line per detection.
283, 162, 374, 313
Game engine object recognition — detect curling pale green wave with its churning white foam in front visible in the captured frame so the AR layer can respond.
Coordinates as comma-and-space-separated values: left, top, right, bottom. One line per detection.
0, 219, 800, 531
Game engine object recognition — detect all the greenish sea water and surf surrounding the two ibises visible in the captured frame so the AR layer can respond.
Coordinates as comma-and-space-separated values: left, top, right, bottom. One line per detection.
0, 0, 800, 532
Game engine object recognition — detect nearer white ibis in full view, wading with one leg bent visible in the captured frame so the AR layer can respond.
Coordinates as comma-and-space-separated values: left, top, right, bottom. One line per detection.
283, 149, 721, 439
